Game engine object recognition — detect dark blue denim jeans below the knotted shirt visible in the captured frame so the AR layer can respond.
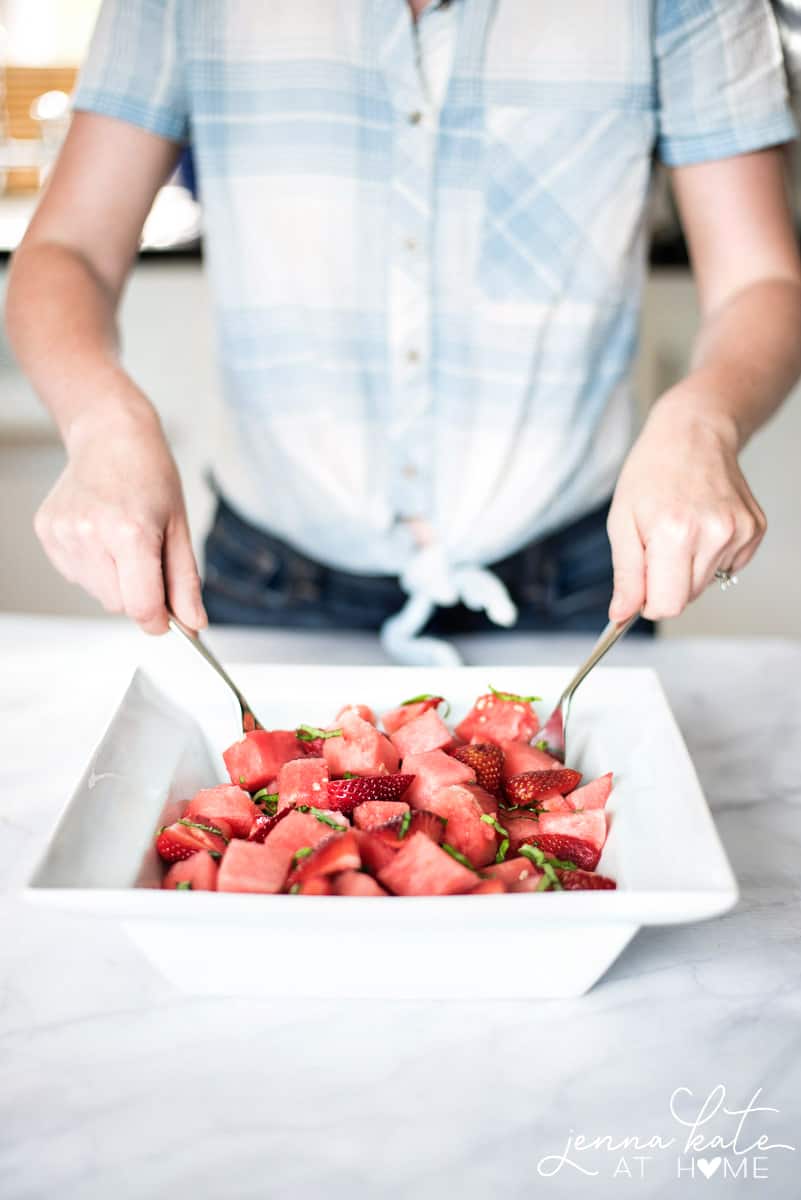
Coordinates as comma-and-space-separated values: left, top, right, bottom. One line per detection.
203, 497, 654, 637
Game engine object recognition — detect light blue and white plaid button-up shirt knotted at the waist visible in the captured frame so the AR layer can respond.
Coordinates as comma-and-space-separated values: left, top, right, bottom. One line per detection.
76, 0, 795, 654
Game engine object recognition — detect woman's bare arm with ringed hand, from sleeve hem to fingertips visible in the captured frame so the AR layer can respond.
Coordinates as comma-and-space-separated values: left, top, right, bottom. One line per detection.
609, 148, 801, 619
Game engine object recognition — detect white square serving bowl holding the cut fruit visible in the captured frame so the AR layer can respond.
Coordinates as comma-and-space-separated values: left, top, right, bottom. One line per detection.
25, 653, 737, 998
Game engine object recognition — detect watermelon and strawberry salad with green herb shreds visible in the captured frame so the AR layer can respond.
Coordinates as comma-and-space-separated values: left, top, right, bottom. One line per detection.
156, 688, 615, 896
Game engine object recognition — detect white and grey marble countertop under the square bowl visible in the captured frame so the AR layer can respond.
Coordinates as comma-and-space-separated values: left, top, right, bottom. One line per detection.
0, 617, 801, 1200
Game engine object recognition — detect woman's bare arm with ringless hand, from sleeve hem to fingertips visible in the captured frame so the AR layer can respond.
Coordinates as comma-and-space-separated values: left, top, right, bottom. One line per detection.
6, 113, 205, 632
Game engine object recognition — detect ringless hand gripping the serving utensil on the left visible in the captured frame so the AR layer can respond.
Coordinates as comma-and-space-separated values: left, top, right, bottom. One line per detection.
34, 400, 207, 634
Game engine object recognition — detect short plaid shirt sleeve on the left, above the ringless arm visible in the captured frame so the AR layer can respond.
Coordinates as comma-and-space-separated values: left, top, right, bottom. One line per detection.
73, 0, 188, 142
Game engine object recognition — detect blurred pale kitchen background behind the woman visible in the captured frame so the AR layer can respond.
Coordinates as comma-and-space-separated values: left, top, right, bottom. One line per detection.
0, 0, 801, 636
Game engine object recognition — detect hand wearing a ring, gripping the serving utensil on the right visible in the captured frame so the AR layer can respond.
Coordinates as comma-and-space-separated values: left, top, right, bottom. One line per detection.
607, 384, 767, 620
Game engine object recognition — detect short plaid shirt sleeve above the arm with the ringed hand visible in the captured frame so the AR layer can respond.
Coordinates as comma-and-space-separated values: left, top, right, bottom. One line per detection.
655, 0, 797, 167
